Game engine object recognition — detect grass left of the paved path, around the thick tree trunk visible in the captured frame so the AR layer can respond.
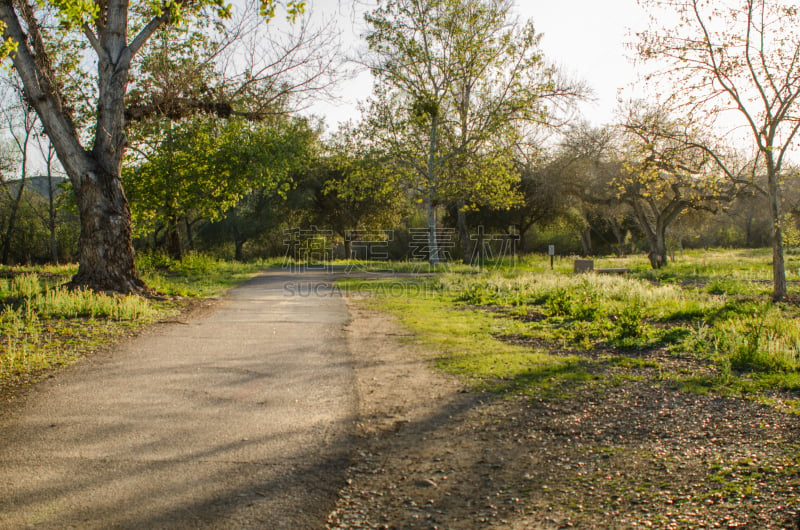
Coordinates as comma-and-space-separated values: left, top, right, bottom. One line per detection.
0, 254, 272, 393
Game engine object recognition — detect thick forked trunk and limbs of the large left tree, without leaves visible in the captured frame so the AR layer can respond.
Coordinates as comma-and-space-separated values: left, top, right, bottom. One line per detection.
0, 0, 161, 294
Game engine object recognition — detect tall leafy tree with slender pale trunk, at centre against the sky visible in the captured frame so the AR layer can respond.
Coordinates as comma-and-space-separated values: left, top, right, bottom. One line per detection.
366, 0, 572, 264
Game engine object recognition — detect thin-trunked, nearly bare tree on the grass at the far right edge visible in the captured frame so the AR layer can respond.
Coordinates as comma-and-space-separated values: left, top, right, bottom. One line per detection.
638, 0, 800, 301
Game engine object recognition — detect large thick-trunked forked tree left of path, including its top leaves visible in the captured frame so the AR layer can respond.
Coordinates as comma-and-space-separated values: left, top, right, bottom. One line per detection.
0, 0, 305, 293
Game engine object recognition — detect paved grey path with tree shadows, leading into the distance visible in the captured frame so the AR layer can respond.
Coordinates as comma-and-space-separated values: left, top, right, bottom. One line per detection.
0, 271, 356, 529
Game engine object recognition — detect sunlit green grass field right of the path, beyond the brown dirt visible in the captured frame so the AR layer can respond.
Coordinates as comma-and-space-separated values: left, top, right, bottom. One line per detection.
340, 250, 800, 400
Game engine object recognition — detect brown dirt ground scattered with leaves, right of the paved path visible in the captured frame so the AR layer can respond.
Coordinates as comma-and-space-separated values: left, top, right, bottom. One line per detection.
328, 302, 800, 529
